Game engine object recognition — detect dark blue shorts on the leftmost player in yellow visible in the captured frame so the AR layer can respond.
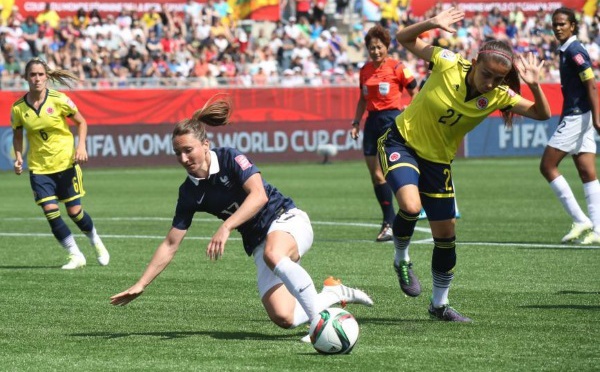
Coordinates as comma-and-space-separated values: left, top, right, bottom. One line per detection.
29, 164, 85, 206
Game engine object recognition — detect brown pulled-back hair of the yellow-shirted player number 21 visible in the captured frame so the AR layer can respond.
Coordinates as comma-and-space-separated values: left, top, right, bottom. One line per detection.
477, 40, 521, 127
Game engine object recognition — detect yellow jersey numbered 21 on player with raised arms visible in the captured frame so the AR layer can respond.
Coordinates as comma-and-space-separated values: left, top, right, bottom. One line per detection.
396, 47, 522, 164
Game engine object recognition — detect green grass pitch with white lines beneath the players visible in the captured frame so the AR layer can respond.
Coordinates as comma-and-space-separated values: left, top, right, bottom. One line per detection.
0, 158, 600, 371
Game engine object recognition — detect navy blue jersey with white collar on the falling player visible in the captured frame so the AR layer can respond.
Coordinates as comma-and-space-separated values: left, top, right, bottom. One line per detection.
173, 147, 296, 255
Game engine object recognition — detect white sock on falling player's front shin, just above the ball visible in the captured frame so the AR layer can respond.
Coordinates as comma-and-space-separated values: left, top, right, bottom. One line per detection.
273, 257, 320, 323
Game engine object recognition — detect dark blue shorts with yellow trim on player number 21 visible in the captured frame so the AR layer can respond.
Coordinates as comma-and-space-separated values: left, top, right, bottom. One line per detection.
378, 126, 456, 221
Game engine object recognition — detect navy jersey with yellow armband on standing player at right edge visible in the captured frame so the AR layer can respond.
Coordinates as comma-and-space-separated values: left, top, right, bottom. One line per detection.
560, 36, 594, 116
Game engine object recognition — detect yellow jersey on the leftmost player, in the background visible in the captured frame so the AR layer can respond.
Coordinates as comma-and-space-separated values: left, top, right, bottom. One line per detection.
10, 89, 77, 174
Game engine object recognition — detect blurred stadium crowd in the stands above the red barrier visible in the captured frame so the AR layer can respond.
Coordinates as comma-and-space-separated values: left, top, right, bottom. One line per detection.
0, 0, 600, 89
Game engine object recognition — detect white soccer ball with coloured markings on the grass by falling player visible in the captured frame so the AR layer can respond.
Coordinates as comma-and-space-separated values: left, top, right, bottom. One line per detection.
309, 307, 359, 354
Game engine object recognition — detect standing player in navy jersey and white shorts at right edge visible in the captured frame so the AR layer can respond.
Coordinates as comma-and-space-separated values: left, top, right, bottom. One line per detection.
540, 8, 600, 244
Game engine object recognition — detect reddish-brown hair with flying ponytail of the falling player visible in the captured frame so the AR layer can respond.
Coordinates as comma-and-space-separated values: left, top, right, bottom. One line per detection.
172, 94, 231, 141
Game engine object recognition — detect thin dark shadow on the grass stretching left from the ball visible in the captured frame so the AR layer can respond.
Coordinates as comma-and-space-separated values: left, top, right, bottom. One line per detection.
69, 331, 306, 341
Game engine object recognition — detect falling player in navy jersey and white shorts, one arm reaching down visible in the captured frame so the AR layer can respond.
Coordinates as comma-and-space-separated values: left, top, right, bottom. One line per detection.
111, 98, 373, 328
